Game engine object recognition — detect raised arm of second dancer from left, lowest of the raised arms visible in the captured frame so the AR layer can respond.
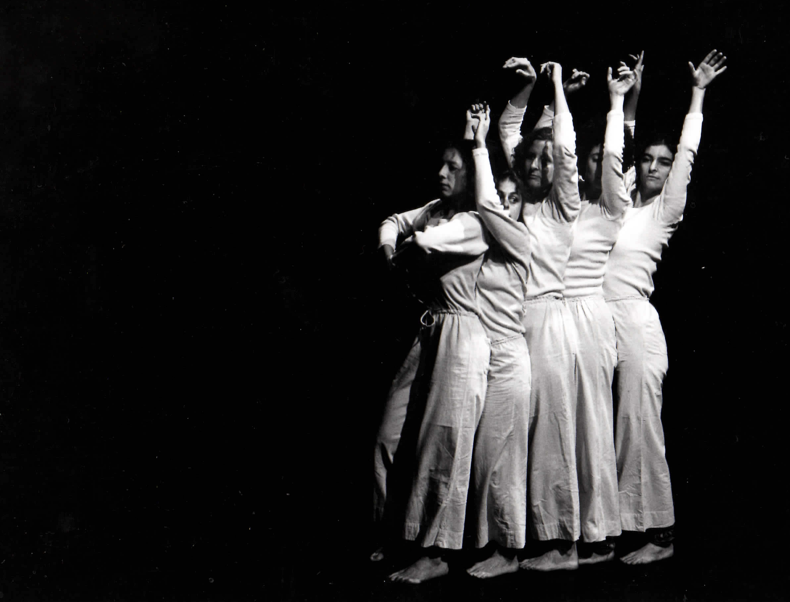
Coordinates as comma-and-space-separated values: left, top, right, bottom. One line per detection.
472, 106, 529, 266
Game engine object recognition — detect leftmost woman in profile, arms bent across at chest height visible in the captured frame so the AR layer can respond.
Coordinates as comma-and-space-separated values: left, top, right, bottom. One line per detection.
380, 141, 490, 583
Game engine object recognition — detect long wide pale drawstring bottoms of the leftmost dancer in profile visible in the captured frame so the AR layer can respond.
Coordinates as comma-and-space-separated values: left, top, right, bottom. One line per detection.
401, 312, 490, 549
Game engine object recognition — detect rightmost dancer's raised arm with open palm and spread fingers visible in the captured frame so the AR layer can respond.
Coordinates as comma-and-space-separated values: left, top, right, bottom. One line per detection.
657, 50, 727, 224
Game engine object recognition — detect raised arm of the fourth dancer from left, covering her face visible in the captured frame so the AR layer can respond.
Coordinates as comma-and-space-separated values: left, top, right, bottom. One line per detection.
601, 67, 636, 219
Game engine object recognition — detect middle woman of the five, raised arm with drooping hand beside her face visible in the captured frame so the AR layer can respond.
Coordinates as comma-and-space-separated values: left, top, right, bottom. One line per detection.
504, 63, 581, 570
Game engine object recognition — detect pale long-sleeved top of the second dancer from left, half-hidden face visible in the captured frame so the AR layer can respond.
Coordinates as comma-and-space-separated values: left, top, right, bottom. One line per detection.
472, 148, 530, 341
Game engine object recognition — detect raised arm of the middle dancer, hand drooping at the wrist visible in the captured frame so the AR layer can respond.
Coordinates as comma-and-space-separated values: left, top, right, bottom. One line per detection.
542, 63, 581, 222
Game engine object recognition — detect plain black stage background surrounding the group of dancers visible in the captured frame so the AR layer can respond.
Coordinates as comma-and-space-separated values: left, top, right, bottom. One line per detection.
0, 0, 790, 601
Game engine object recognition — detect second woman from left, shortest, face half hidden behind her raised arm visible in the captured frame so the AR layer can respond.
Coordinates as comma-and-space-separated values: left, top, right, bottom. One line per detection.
467, 105, 530, 578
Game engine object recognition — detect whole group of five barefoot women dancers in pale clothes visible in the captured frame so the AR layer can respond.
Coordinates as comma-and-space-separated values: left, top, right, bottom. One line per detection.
371, 50, 726, 583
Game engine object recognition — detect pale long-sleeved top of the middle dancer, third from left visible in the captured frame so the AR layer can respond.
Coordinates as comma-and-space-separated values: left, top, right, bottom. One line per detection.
522, 113, 581, 298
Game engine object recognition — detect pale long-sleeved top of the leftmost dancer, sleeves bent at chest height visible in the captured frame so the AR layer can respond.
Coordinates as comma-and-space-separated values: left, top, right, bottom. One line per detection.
379, 200, 488, 313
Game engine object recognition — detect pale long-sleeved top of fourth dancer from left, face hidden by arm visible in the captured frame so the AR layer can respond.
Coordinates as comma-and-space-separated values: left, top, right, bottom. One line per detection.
564, 111, 631, 297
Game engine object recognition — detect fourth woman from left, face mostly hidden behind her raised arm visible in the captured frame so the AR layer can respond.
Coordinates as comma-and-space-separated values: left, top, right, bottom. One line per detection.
563, 69, 635, 564
